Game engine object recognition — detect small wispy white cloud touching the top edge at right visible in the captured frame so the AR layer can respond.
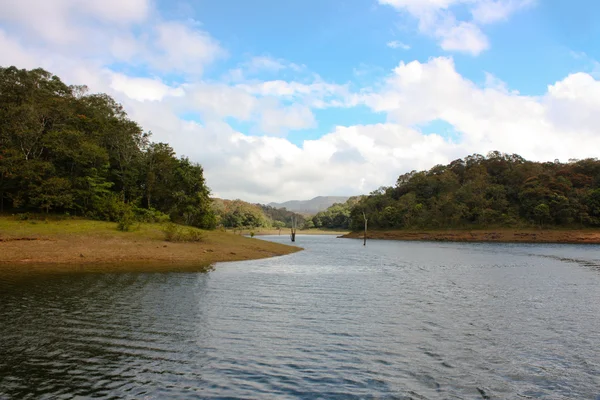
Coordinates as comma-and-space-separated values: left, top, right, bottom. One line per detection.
379, 0, 536, 55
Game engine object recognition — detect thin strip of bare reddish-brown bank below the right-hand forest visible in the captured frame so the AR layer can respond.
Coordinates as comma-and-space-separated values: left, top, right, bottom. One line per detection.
342, 229, 600, 244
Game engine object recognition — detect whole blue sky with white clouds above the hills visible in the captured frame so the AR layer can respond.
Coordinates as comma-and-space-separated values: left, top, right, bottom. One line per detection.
0, 0, 600, 203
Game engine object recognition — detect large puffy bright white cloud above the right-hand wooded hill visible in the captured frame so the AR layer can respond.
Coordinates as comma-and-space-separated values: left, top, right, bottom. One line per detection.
362, 58, 600, 160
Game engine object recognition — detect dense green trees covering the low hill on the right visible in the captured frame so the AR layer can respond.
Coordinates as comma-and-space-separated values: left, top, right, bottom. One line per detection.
313, 152, 600, 230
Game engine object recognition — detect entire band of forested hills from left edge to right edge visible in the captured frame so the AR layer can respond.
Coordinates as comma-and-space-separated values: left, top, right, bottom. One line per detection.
0, 67, 600, 230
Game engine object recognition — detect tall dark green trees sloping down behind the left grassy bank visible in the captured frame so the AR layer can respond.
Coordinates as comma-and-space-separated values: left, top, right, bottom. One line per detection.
0, 67, 217, 228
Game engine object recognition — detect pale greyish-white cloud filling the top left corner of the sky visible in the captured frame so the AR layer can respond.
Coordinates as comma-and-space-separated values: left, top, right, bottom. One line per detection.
0, 0, 226, 75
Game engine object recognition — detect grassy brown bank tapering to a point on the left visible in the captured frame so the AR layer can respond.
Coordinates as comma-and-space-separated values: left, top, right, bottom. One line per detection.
0, 217, 301, 271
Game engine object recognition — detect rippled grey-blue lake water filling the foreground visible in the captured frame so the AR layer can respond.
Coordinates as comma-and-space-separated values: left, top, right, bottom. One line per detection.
0, 236, 600, 399
